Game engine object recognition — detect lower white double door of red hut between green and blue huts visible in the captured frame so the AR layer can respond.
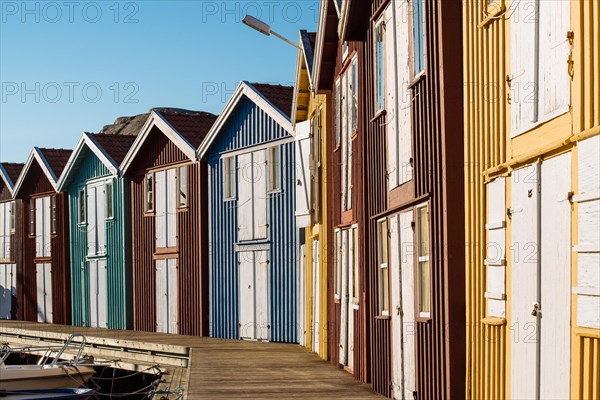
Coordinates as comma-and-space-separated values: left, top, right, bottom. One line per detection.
156, 259, 179, 333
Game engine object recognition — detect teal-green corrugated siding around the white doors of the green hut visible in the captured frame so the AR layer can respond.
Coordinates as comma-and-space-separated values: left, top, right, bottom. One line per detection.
68, 150, 131, 329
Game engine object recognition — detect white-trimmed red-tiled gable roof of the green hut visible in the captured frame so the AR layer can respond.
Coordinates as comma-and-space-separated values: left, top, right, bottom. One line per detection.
57, 132, 135, 191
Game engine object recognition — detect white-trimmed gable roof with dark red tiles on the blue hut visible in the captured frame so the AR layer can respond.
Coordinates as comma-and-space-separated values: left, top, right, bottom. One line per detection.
197, 81, 294, 159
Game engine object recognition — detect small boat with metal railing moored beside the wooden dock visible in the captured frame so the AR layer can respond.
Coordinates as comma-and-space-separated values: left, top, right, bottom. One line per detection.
0, 334, 95, 399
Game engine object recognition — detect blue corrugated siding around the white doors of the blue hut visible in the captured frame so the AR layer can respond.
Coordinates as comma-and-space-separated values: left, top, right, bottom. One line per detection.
207, 97, 301, 342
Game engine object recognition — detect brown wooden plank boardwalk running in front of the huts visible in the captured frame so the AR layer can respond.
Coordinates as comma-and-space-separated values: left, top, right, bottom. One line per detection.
0, 321, 382, 399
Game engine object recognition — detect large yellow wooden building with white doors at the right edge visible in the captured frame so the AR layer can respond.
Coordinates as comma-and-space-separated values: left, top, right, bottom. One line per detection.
463, 0, 600, 399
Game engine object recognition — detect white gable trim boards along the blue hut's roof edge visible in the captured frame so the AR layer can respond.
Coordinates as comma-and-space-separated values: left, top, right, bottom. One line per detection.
197, 81, 294, 159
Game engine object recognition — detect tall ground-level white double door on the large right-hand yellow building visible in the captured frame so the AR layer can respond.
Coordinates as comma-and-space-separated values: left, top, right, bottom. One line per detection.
509, 153, 572, 399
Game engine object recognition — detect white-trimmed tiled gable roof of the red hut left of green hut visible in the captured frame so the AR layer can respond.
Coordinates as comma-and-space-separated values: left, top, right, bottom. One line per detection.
13, 147, 73, 196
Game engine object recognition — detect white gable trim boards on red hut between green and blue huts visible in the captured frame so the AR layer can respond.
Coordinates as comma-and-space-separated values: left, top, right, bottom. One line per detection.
120, 110, 196, 174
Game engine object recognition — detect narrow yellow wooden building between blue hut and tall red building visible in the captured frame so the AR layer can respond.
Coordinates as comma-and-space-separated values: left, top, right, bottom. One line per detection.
292, 30, 331, 359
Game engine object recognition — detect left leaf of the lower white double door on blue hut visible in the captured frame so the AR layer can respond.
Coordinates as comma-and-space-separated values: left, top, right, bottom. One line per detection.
238, 251, 256, 339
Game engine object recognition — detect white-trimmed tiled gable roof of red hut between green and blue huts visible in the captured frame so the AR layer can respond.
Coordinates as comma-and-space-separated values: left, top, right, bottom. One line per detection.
120, 108, 217, 173
